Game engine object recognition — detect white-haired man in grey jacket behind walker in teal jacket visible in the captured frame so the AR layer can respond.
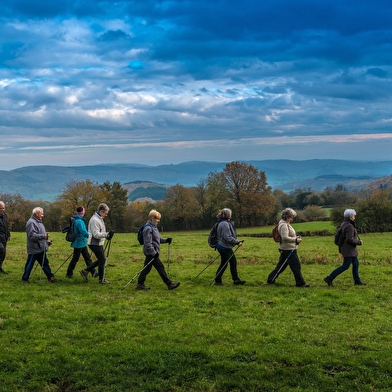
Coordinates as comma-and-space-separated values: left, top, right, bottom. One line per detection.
22, 207, 59, 283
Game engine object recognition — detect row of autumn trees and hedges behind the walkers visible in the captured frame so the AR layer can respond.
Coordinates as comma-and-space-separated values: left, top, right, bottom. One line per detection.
0, 161, 392, 232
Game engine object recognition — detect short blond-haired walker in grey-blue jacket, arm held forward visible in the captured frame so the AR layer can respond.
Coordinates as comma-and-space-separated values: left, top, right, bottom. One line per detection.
136, 210, 180, 290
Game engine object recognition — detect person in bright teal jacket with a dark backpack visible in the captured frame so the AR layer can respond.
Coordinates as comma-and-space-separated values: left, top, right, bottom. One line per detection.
65, 206, 95, 279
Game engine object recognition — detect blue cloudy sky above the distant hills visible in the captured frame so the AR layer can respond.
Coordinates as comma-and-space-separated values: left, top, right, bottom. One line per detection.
0, 0, 392, 170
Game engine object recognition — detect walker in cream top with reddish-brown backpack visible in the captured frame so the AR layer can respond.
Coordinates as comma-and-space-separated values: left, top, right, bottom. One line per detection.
267, 208, 309, 287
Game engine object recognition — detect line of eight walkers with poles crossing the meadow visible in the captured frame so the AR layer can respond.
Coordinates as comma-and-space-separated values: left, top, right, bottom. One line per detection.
0, 201, 366, 290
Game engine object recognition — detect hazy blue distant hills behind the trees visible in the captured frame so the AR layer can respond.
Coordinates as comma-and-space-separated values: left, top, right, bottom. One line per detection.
0, 159, 392, 201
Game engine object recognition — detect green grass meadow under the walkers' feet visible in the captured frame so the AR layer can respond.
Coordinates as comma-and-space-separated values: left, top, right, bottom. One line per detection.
0, 222, 392, 392
